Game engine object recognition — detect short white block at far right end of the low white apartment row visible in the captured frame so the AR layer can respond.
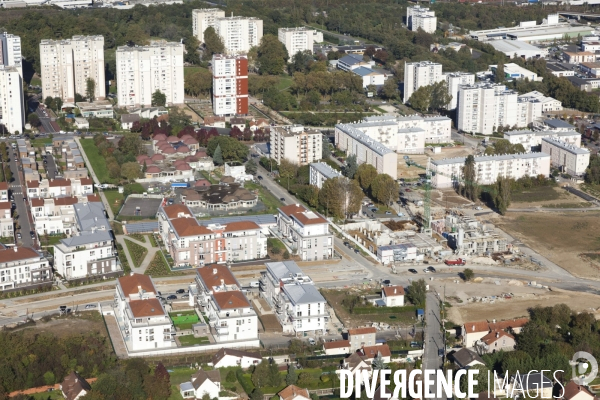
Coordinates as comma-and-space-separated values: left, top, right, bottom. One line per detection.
542, 137, 590, 176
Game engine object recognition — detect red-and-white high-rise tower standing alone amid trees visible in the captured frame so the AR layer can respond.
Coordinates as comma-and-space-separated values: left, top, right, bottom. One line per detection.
212, 54, 248, 116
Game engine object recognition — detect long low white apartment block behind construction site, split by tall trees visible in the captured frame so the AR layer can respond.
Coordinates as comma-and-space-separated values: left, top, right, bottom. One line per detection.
431, 153, 550, 188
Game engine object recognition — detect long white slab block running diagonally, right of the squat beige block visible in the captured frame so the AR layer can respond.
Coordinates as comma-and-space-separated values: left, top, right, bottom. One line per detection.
332, 124, 398, 179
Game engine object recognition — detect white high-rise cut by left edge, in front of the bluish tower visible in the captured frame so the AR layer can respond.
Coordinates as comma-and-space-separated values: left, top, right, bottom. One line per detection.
0, 65, 25, 133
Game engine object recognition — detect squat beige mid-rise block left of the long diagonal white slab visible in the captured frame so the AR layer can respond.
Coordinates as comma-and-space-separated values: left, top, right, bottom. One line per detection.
271, 125, 323, 165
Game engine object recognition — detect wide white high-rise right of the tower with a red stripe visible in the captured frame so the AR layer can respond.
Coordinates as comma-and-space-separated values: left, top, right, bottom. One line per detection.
117, 41, 184, 107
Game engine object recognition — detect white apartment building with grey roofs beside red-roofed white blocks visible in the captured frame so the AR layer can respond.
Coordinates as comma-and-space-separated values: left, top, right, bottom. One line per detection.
259, 261, 329, 334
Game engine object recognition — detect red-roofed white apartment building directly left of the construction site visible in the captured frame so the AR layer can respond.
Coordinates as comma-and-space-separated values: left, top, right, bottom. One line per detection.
277, 204, 333, 261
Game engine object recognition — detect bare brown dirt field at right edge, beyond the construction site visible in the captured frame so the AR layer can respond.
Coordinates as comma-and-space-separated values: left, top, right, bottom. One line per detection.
495, 212, 600, 279
